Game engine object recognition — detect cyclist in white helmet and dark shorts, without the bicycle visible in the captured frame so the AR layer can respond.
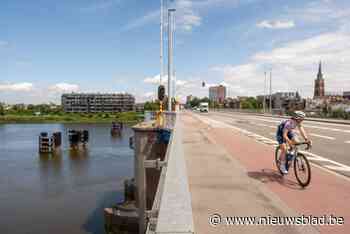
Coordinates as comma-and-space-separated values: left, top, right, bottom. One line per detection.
276, 111, 312, 174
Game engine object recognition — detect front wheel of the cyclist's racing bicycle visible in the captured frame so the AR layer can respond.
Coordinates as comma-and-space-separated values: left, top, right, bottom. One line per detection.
293, 153, 311, 187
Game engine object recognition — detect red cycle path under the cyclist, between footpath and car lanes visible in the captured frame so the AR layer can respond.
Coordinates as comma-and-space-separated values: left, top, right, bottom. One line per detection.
207, 123, 350, 234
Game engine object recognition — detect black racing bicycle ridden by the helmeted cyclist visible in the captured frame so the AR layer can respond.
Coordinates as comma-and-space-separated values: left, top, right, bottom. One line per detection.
275, 142, 311, 187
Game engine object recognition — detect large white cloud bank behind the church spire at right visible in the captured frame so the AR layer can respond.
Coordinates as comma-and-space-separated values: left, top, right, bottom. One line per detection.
211, 28, 350, 96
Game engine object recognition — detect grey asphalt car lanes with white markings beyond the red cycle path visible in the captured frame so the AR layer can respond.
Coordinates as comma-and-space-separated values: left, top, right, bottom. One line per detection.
200, 112, 350, 177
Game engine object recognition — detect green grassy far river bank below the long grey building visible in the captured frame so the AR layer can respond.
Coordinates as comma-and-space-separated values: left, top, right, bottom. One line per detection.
0, 112, 144, 124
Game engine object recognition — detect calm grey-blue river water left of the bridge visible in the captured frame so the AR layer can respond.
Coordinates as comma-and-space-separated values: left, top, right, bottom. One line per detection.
0, 124, 133, 234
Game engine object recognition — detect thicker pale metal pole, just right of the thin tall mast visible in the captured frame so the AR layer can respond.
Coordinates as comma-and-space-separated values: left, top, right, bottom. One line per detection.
168, 9, 175, 111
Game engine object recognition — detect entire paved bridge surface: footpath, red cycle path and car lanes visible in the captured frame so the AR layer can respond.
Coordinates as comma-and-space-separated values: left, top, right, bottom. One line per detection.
187, 112, 350, 234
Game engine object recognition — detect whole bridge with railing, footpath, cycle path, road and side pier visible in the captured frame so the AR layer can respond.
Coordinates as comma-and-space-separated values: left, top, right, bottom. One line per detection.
104, 111, 350, 234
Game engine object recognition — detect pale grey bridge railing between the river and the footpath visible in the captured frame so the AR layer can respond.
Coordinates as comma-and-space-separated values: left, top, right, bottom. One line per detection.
146, 113, 194, 234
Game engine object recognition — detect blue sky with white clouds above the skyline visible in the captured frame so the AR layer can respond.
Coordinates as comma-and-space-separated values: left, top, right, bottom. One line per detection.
0, 0, 350, 104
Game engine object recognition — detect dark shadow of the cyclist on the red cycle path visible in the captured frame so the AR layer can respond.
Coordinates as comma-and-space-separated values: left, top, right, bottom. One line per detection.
247, 169, 303, 190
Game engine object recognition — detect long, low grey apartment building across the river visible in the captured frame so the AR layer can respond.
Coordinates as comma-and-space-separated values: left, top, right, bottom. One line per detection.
62, 93, 135, 113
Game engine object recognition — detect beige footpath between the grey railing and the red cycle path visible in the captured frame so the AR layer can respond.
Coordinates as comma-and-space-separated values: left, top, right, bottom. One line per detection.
180, 113, 318, 233
